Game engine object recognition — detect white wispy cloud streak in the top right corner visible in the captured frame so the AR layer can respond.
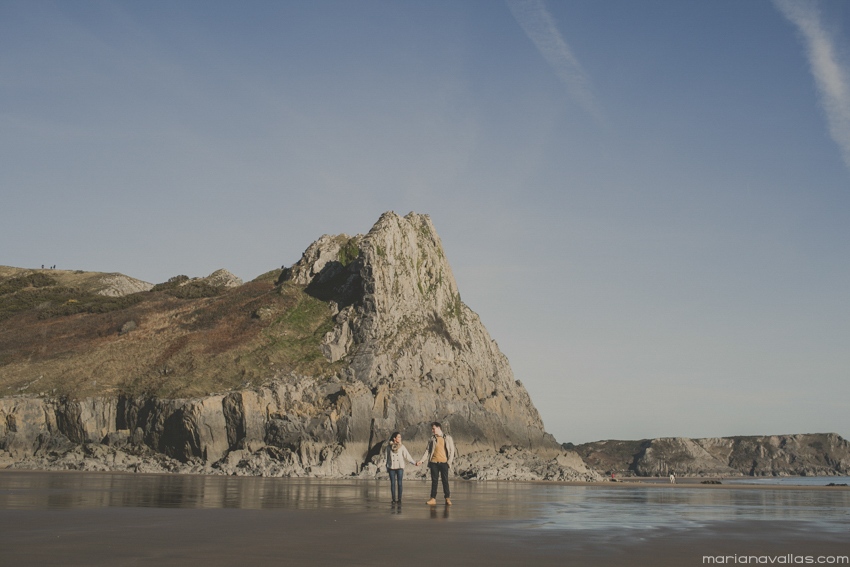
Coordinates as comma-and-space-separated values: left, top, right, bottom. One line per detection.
773, 0, 850, 173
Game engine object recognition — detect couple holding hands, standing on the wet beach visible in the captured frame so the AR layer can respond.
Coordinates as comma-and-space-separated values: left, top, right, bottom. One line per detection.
386, 421, 455, 506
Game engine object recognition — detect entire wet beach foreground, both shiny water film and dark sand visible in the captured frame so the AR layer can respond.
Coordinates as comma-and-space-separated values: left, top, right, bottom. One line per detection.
0, 473, 850, 567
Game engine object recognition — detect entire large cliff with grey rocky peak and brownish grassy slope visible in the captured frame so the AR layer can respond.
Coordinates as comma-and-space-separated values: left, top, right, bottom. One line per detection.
0, 213, 597, 480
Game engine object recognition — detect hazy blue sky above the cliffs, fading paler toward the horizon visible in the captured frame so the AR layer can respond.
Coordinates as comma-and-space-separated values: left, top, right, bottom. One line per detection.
0, 0, 850, 443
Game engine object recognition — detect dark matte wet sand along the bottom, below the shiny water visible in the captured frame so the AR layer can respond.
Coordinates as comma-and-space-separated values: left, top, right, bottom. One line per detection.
0, 503, 850, 566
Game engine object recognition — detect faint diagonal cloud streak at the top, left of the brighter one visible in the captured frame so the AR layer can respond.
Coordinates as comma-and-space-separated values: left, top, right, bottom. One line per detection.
506, 0, 602, 120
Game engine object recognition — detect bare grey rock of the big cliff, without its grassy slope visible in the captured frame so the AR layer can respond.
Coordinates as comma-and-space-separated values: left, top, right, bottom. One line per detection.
0, 213, 598, 480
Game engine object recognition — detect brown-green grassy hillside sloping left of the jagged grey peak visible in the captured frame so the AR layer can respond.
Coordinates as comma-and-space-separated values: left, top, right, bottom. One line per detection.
0, 268, 342, 397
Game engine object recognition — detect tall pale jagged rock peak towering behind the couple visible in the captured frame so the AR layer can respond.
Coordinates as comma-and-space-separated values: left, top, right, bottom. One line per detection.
282, 212, 554, 454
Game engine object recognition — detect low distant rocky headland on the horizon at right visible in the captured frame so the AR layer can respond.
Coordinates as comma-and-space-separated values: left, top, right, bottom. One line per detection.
575, 433, 850, 476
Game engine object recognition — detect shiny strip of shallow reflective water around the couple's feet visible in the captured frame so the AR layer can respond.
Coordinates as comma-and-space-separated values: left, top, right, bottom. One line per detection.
0, 471, 850, 533
